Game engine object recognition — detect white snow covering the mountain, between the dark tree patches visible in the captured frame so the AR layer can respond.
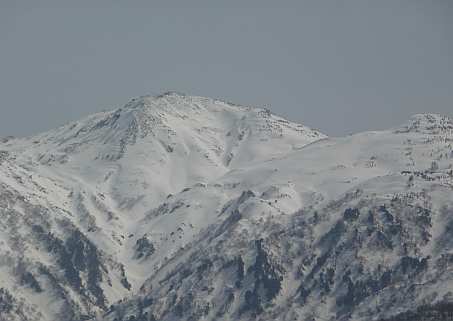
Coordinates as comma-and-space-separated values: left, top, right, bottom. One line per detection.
0, 93, 453, 321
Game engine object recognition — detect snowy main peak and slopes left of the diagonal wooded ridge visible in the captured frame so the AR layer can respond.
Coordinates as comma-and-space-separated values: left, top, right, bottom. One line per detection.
0, 93, 325, 320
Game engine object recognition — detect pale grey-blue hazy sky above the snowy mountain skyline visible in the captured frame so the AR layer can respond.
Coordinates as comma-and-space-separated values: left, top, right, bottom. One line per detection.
0, 0, 453, 136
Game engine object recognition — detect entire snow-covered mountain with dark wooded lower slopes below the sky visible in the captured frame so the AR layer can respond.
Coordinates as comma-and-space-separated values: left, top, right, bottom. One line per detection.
0, 93, 453, 321
